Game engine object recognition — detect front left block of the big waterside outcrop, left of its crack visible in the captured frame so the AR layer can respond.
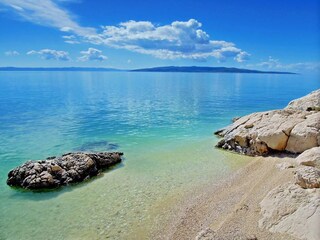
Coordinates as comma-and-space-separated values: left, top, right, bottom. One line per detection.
217, 110, 310, 155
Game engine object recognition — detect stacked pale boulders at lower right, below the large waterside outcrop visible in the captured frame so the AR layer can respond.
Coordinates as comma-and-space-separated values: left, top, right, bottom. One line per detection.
259, 143, 320, 240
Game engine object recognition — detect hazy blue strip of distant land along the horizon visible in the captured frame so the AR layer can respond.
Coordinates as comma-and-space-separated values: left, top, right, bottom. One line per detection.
0, 66, 296, 74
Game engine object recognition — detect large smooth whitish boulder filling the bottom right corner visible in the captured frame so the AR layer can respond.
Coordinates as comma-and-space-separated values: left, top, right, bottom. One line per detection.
259, 183, 320, 240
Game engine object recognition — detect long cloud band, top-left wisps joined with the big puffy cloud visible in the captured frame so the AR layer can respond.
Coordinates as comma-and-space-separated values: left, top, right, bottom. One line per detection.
0, 0, 249, 62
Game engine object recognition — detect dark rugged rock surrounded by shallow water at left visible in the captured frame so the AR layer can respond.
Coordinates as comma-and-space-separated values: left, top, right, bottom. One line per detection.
7, 152, 123, 189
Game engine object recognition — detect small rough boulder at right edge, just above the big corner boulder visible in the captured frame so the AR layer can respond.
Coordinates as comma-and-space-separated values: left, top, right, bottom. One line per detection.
295, 167, 320, 188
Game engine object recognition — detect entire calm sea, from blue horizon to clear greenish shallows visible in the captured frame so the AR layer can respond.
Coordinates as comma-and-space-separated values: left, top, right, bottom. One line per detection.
0, 72, 320, 239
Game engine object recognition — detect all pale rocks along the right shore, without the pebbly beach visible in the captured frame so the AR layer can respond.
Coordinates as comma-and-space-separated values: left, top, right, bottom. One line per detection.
210, 89, 320, 240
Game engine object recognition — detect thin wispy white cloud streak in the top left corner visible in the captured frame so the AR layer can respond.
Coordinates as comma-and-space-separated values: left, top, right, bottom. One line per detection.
0, 0, 95, 36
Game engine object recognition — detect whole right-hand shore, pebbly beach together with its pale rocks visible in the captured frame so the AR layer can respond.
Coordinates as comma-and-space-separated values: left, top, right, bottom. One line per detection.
154, 89, 320, 240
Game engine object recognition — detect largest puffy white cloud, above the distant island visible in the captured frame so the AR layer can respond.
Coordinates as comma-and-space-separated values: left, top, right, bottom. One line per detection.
86, 19, 249, 62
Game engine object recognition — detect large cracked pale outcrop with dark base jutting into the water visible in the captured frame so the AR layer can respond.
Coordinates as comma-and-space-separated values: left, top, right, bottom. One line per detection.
215, 89, 320, 155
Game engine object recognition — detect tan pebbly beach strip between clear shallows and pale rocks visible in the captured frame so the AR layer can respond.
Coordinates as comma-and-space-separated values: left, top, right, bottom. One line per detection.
152, 156, 295, 240
